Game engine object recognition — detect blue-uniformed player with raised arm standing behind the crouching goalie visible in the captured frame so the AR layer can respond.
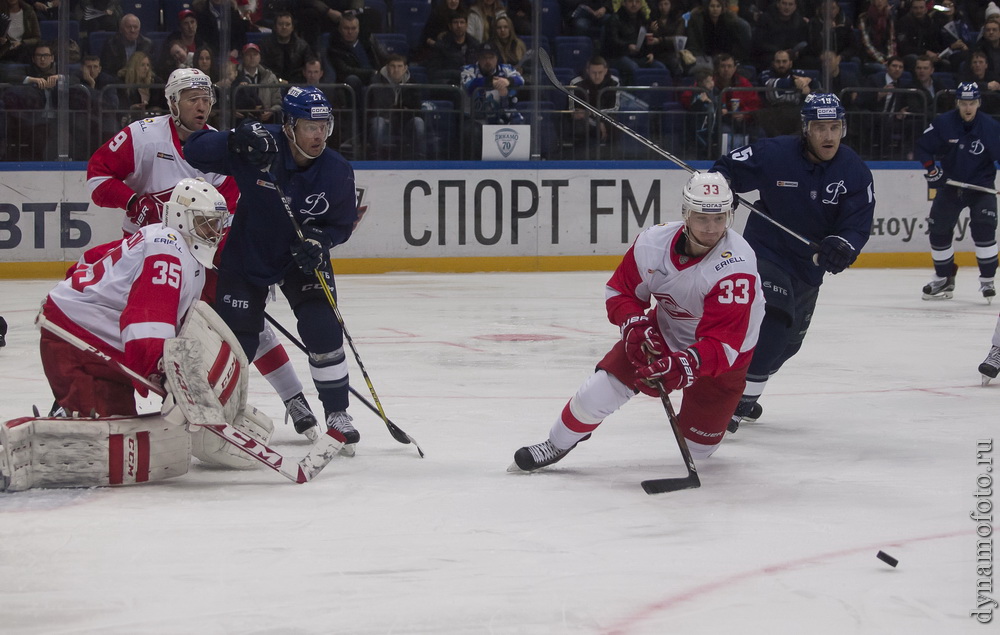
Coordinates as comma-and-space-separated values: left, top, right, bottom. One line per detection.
184, 86, 360, 454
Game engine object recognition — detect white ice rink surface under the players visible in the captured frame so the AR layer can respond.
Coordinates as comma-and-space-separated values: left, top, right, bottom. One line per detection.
0, 268, 1000, 635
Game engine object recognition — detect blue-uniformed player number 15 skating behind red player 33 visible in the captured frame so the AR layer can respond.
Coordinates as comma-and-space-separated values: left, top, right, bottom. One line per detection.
712, 93, 875, 432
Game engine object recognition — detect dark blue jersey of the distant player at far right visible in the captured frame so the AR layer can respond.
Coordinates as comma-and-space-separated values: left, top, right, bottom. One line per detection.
913, 110, 1000, 189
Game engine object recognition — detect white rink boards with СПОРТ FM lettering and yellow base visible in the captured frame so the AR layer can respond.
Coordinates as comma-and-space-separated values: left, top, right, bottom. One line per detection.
0, 161, 975, 278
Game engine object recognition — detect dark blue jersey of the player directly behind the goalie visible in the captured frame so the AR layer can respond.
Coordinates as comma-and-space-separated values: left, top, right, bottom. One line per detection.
184, 125, 358, 286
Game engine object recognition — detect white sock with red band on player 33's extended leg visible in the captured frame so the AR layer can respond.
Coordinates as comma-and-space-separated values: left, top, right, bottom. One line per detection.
549, 370, 635, 450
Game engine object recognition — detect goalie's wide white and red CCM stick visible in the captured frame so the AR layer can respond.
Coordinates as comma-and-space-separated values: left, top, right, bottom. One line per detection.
36, 313, 345, 483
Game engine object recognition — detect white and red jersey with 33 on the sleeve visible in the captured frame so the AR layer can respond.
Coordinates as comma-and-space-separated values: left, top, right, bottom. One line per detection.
606, 222, 764, 377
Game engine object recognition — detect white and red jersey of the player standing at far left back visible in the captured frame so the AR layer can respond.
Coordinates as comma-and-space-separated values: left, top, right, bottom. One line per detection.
87, 115, 240, 236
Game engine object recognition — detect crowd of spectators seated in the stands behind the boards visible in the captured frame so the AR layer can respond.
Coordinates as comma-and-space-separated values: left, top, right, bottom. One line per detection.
0, 0, 1000, 160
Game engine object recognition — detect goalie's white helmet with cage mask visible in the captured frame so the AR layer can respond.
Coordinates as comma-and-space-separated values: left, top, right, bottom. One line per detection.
163, 178, 229, 268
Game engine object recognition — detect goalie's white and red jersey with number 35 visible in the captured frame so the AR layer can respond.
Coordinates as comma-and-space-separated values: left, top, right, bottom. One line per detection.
42, 224, 205, 377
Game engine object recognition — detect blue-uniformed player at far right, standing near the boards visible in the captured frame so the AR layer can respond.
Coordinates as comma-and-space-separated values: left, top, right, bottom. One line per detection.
914, 82, 1000, 302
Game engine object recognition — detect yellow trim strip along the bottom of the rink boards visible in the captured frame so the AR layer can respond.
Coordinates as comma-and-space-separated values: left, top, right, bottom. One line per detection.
0, 252, 976, 280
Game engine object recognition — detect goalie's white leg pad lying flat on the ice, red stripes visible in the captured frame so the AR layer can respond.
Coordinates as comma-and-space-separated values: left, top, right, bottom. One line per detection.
0, 414, 191, 492
